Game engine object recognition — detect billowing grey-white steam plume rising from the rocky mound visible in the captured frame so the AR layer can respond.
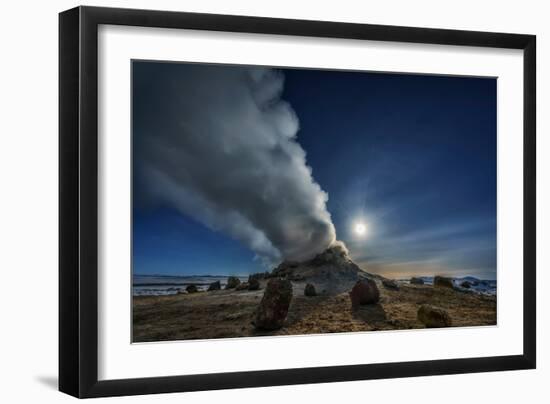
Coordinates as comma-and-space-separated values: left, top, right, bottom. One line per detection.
133, 63, 335, 262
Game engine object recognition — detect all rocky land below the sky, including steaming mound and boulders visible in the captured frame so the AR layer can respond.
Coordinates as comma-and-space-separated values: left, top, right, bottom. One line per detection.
133, 245, 496, 342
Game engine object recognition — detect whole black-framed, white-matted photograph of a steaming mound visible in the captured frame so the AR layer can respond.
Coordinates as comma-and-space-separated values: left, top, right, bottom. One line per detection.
59, 7, 536, 397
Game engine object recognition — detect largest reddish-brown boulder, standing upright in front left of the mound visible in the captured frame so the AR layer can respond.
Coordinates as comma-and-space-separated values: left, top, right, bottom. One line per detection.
254, 278, 292, 330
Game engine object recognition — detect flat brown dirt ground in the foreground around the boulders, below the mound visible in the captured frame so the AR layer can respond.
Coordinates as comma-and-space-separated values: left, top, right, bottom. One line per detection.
133, 283, 497, 342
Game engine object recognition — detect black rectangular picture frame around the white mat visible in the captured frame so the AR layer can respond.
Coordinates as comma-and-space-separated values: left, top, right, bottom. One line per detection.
59, 7, 536, 398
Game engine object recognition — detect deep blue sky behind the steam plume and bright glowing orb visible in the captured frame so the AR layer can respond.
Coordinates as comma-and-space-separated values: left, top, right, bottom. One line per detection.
133, 62, 497, 279
